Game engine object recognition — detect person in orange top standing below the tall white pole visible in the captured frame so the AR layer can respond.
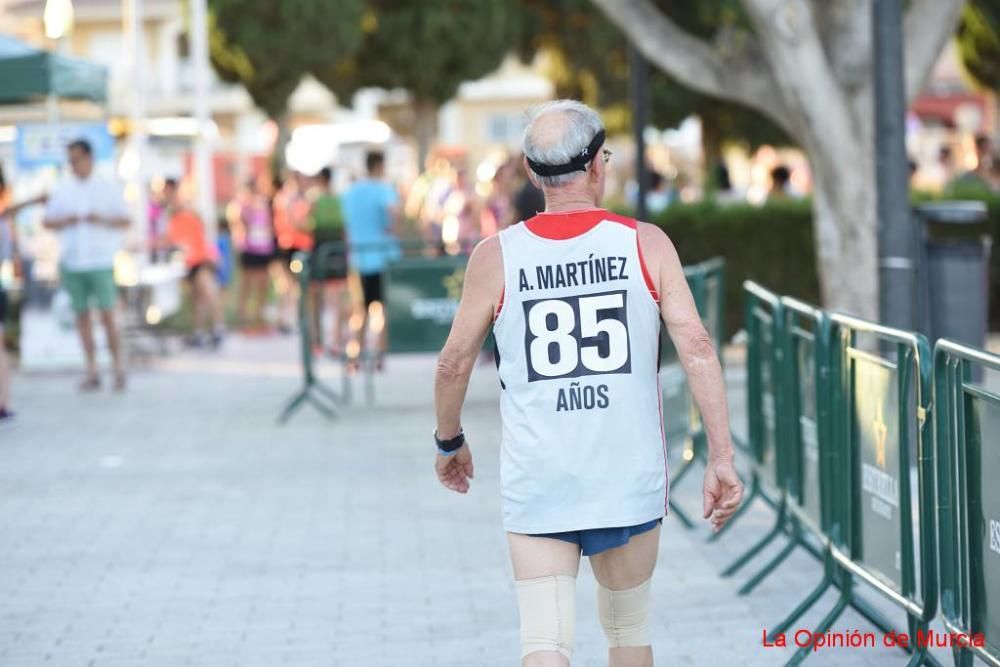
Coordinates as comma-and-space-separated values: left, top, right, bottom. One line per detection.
162, 178, 222, 348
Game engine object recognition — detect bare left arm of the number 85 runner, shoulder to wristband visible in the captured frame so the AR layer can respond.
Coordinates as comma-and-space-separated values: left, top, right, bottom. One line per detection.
434, 236, 503, 439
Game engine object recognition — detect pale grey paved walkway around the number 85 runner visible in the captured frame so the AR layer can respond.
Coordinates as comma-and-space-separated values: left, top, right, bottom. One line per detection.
0, 338, 948, 667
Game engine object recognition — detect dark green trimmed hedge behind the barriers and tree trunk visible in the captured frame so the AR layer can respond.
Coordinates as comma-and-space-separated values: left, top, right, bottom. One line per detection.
653, 189, 1000, 336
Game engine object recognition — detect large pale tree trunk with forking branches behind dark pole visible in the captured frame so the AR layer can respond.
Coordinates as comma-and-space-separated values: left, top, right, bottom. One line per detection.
593, 0, 964, 319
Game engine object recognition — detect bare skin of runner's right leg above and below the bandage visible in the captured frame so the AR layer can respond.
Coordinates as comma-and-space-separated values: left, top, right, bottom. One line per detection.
590, 526, 660, 667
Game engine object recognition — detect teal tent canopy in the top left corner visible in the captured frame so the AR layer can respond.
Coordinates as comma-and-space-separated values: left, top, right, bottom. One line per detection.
0, 34, 108, 104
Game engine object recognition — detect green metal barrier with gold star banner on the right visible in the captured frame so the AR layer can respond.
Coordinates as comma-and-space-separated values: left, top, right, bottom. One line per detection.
788, 314, 938, 665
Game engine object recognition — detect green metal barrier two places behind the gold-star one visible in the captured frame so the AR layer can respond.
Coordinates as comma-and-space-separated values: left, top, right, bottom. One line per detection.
722, 281, 788, 580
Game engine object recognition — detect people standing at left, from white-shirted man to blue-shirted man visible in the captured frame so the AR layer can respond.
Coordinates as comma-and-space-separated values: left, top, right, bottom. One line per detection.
0, 147, 401, 425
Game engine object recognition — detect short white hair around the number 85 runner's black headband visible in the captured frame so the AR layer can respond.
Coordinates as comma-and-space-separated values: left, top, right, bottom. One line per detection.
522, 100, 604, 188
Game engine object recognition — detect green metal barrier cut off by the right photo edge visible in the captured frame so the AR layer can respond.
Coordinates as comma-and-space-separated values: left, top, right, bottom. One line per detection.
934, 339, 1000, 666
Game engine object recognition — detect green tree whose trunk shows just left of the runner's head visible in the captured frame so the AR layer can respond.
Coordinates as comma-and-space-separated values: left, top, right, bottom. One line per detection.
314, 0, 518, 162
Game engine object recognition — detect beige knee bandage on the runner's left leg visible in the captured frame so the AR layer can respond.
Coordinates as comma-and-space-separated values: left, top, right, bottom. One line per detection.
514, 575, 576, 659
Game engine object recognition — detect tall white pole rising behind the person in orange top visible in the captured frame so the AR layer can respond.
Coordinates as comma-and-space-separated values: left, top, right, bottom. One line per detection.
191, 0, 218, 241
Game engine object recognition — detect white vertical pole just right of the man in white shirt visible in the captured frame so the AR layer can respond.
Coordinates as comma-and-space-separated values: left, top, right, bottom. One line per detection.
122, 0, 149, 241
